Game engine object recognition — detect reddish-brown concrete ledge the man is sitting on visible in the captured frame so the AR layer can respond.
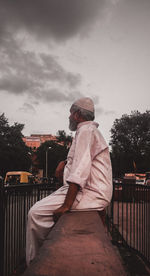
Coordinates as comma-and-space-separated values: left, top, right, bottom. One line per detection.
23, 211, 127, 276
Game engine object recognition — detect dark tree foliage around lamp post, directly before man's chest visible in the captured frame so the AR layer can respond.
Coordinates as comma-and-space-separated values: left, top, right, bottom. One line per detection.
36, 130, 72, 176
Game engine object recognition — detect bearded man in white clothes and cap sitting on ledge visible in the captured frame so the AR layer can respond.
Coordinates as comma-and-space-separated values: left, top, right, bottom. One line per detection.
26, 97, 112, 265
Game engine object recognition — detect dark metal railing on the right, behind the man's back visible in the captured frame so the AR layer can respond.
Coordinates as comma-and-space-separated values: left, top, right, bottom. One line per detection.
107, 183, 150, 264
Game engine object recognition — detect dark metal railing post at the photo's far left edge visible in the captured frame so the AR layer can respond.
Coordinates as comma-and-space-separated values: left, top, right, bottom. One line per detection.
0, 180, 5, 276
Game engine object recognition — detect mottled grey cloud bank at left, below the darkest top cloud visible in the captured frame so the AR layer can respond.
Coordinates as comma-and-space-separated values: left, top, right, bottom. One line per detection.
0, 35, 81, 101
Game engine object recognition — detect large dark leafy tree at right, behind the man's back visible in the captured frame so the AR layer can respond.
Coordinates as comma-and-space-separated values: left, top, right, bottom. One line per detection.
110, 111, 150, 176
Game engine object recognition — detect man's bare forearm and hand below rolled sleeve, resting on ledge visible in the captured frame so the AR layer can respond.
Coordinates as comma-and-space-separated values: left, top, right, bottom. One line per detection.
53, 183, 79, 222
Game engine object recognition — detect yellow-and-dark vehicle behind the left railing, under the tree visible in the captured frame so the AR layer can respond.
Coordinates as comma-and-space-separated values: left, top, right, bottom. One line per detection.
4, 171, 33, 186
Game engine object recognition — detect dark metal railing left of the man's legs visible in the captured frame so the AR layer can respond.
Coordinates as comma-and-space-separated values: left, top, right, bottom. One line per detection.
0, 180, 56, 276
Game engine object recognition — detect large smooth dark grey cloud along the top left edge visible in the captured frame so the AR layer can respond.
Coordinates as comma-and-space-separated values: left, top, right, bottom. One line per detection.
0, 0, 105, 41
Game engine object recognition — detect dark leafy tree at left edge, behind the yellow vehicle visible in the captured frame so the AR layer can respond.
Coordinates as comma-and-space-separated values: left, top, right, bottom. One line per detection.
0, 113, 30, 177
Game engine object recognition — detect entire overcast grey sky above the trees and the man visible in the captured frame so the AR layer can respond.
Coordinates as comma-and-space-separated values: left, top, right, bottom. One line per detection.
0, 0, 150, 143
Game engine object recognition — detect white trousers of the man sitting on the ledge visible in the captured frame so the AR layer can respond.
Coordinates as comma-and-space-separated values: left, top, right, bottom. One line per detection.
26, 186, 108, 265
